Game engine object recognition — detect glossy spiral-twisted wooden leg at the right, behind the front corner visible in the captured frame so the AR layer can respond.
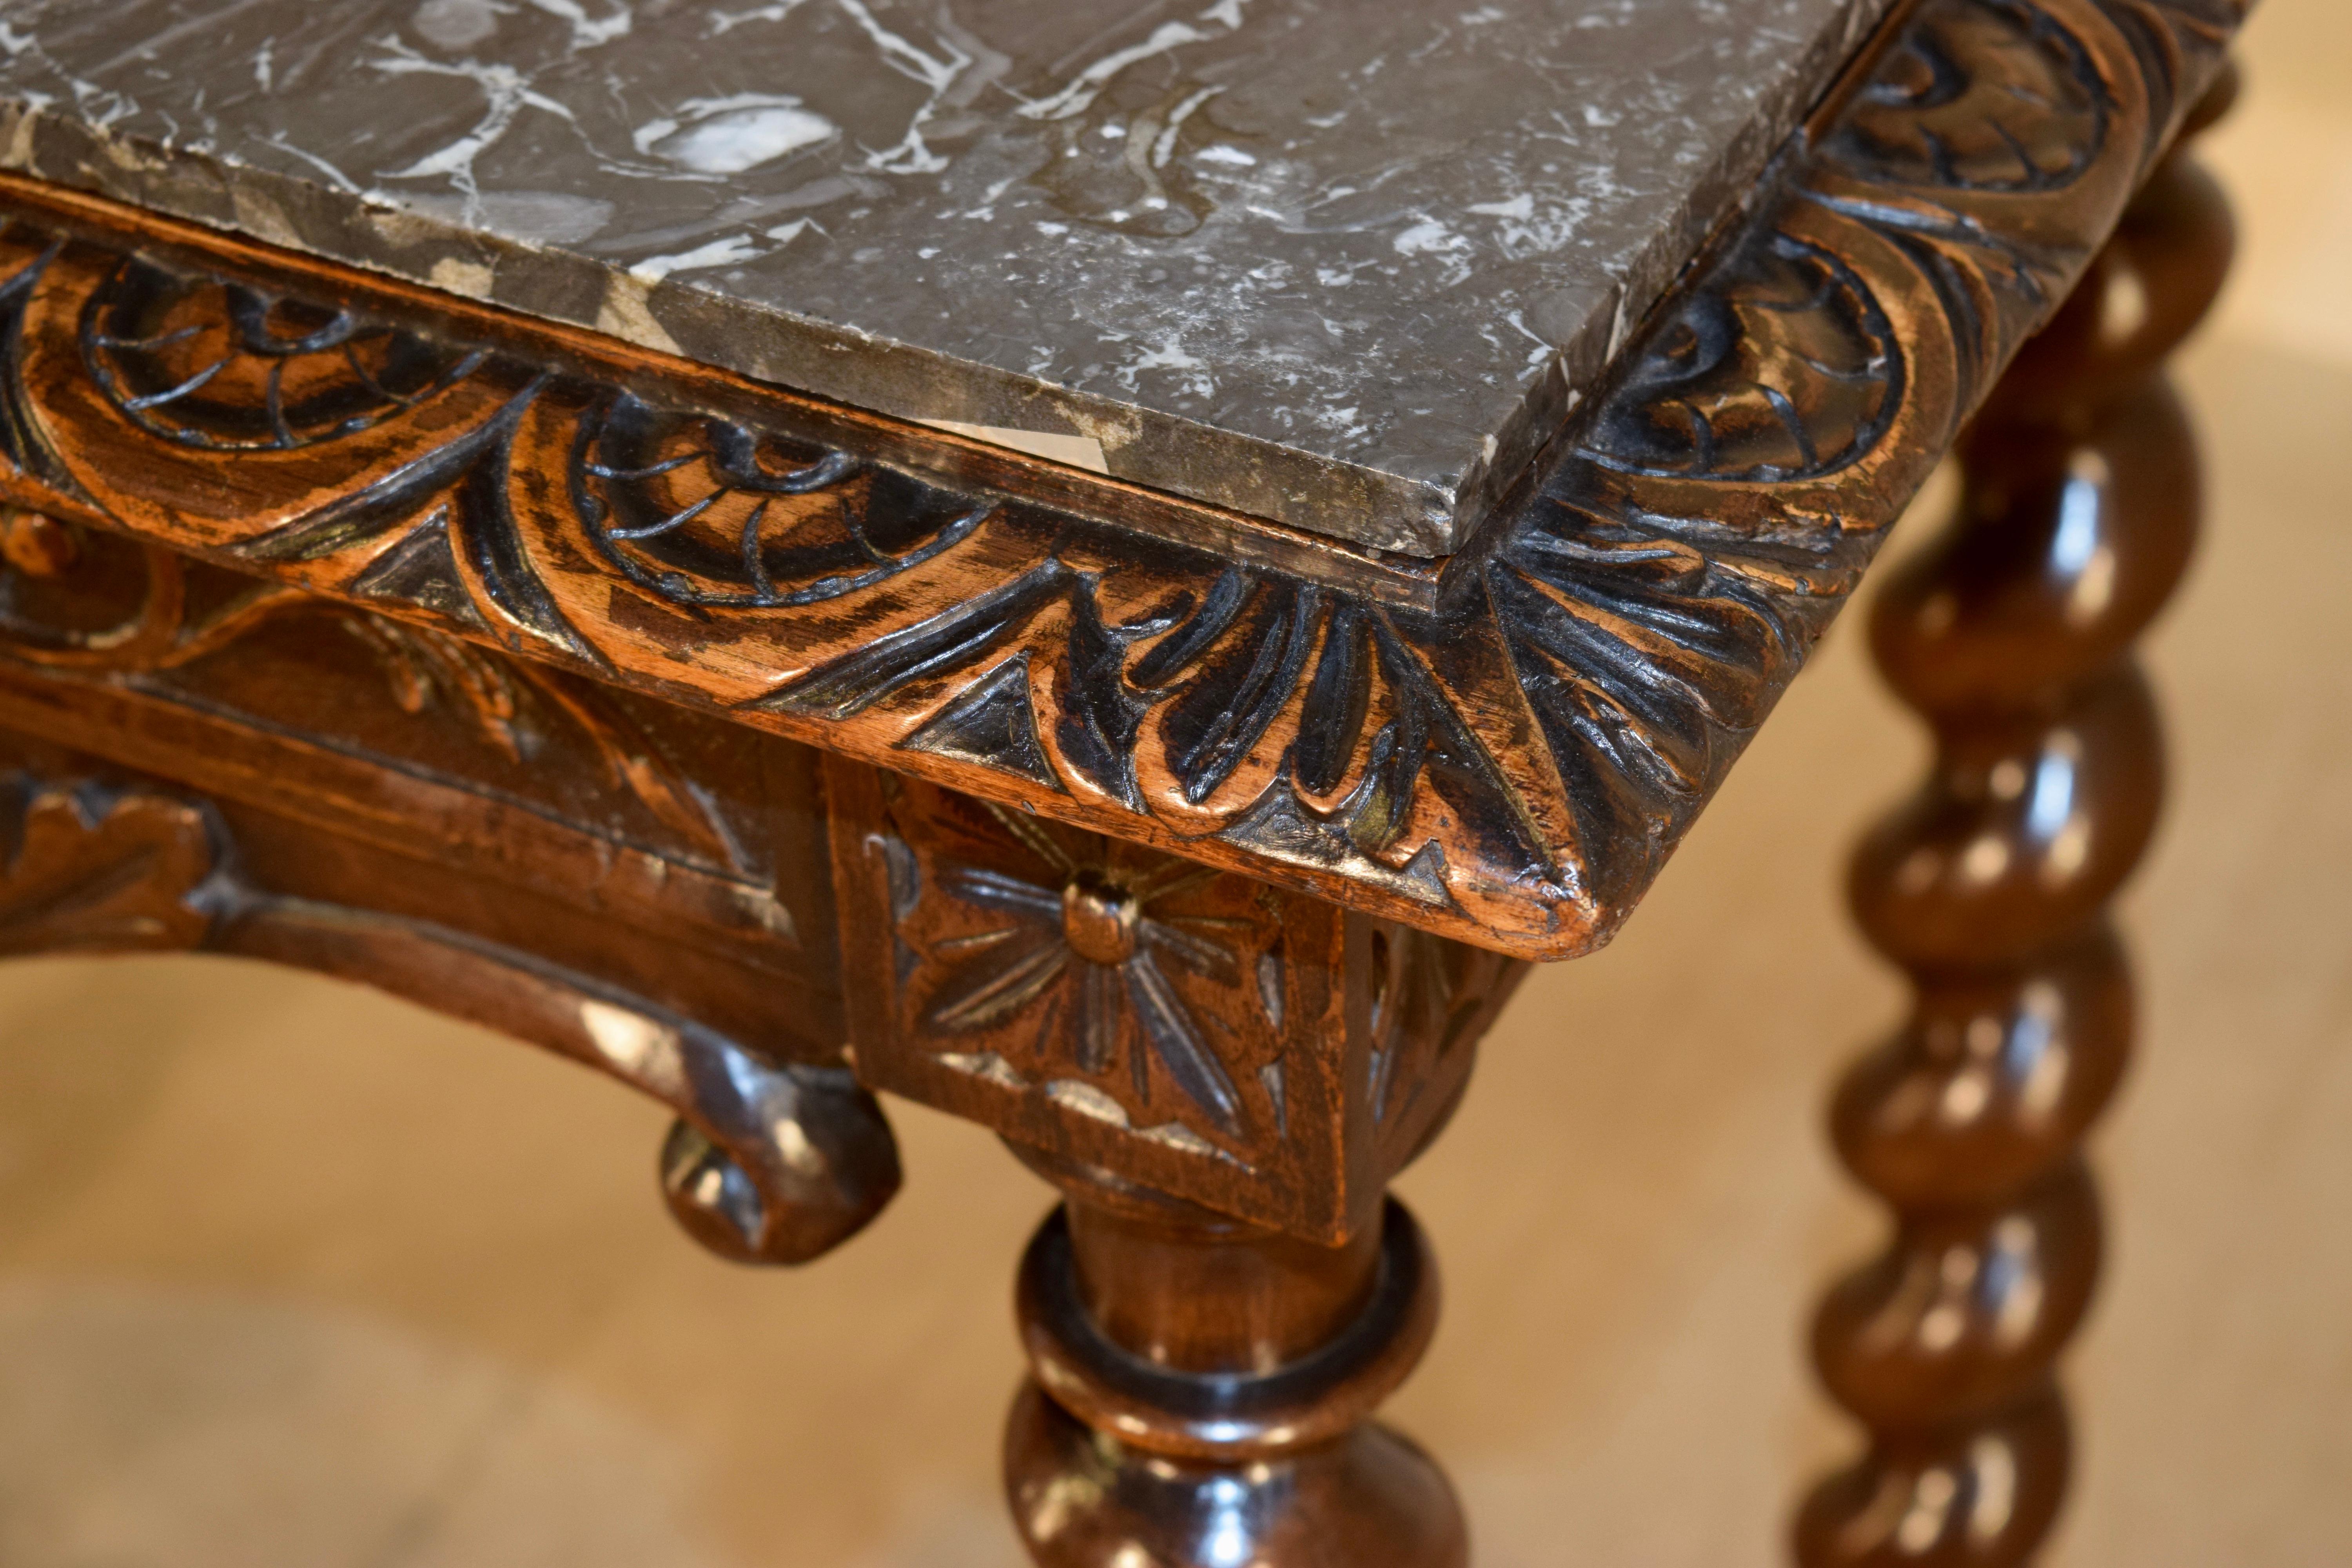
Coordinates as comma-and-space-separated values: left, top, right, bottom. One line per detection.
1797, 80, 2232, 1566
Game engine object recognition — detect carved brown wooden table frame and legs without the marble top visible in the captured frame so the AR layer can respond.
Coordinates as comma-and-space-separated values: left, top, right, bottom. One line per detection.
0, 0, 2244, 1568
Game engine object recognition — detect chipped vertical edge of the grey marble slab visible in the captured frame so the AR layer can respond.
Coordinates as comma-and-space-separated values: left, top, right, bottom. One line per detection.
0, 0, 1903, 557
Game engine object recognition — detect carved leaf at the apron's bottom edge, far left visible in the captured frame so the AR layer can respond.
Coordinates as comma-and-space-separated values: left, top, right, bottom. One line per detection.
0, 773, 214, 952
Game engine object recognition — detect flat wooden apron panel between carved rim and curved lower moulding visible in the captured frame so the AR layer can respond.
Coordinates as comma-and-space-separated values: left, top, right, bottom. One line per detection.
0, 512, 847, 1065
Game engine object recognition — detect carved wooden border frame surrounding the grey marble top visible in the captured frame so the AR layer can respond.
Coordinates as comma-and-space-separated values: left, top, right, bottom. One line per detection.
0, 0, 2244, 957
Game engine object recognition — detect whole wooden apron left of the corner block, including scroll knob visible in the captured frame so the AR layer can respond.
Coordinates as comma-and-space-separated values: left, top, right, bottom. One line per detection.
0, 526, 898, 1262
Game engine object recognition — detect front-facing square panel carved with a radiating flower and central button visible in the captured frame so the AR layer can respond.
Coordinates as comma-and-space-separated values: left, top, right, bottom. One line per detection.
873, 780, 1291, 1166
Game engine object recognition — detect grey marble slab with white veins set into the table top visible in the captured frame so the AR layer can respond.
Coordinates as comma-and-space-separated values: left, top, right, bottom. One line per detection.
0, 0, 1886, 555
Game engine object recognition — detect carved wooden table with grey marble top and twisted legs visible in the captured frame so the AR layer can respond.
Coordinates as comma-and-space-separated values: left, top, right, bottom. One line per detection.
0, 0, 2246, 1568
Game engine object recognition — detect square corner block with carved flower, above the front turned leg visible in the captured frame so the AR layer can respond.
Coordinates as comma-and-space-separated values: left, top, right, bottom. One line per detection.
828, 762, 1524, 1241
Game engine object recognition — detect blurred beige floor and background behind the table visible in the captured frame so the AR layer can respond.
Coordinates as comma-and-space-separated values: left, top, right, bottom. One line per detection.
0, 0, 2352, 1568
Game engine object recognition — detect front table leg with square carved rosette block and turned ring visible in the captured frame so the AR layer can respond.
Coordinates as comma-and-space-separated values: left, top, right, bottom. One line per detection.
826, 762, 1524, 1568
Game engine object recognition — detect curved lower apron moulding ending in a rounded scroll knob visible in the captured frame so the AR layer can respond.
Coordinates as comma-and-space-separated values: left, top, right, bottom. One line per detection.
0, 738, 898, 1262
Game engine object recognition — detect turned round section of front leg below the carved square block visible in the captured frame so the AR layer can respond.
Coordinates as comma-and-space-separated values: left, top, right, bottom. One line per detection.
1004, 1152, 1468, 1568
